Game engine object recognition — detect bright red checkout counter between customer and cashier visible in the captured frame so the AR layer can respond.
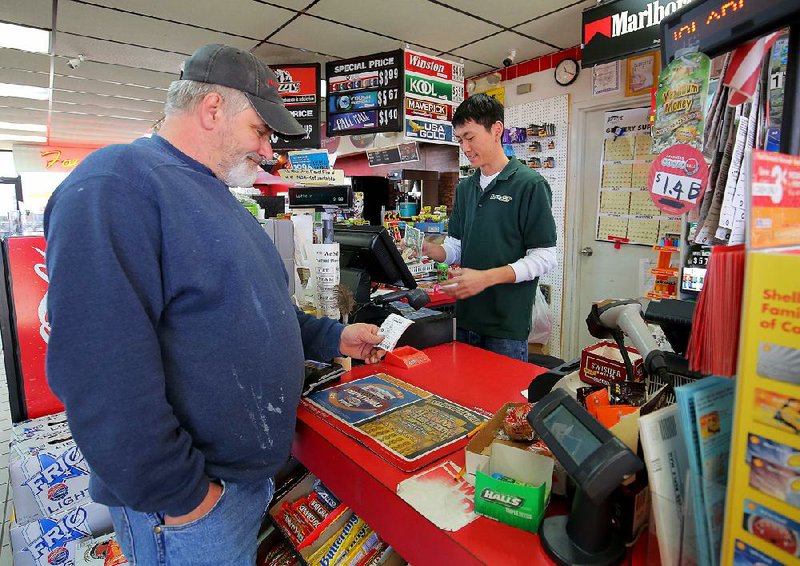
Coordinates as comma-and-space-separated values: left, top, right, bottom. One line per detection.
293, 342, 624, 566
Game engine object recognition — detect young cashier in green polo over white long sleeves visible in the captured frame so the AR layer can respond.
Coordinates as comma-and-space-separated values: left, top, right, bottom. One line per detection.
423, 94, 557, 361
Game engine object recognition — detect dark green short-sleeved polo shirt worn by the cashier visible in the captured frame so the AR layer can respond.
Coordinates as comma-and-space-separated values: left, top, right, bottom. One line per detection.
448, 157, 556, 340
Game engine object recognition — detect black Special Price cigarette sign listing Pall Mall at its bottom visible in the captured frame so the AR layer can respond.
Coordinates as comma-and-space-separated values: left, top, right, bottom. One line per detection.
325, 50, 403, 136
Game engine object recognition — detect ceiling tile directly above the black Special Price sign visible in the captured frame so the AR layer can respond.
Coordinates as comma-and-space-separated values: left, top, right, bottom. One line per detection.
270, 16, 401, 59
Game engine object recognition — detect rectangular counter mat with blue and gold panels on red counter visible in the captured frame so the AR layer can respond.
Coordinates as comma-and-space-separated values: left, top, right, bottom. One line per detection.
301, 373, 486, 472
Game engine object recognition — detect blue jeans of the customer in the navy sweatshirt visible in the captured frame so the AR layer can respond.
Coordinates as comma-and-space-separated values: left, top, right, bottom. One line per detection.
109, 479, 275, 566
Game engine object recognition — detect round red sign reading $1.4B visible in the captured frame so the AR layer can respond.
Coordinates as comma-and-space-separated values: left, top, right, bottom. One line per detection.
648, 144, 708, 216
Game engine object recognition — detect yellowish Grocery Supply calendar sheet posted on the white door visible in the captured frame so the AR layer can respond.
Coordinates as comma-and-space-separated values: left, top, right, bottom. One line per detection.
595, 108, 681, 246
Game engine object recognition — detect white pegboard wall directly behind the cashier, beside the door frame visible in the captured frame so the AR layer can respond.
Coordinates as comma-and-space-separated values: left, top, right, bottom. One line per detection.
505, 94, 569, 357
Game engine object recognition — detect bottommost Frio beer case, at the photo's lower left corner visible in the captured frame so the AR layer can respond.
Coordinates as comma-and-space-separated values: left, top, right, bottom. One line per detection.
11, 501, 113, 566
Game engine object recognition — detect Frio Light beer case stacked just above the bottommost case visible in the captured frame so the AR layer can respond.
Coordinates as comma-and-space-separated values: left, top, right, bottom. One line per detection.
9, 444, 89, 524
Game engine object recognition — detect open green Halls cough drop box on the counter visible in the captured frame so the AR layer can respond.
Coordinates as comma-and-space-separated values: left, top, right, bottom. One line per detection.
475, 444, 554, 533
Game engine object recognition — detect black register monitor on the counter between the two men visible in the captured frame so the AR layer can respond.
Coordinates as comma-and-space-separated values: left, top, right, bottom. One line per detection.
333, 226, 417, 289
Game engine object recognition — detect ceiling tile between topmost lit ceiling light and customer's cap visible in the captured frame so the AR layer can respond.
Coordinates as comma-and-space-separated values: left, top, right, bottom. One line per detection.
56, 33, 186, 78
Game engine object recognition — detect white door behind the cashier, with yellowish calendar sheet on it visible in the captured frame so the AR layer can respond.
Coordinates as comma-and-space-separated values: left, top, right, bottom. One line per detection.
565, 102, 656, 359
